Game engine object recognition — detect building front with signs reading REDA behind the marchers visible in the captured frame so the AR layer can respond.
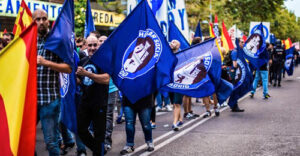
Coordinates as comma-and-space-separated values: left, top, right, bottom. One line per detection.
0, 0, 125, 35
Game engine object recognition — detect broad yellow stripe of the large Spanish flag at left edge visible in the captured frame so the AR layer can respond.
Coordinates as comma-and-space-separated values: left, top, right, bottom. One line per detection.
0, 38, 29, 155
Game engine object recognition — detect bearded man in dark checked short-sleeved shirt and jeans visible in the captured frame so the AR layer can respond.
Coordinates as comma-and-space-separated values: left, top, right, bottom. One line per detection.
32, 10, 72, 156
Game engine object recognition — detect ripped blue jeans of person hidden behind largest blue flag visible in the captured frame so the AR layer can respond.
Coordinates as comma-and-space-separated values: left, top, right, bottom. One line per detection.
124, 106, 152, 146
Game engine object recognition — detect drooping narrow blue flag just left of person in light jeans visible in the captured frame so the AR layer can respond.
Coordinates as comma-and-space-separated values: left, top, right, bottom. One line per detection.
228, 39, 253, 108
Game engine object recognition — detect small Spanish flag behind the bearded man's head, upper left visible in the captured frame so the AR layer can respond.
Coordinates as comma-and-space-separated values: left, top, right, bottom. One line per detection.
13, 0, 32, 36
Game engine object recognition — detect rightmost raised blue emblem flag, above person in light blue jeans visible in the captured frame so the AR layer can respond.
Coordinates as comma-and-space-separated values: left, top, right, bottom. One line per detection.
243, 23, 269, 69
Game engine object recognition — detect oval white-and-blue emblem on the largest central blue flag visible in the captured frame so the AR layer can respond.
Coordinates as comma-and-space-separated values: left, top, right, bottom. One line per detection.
119, 29, 162, 79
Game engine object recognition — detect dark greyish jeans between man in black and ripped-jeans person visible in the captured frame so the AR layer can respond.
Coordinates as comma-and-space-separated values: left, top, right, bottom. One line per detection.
105, 91, 121, 145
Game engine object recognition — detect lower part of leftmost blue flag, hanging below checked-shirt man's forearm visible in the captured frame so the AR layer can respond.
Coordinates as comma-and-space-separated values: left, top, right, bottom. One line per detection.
60, 50, 79, 133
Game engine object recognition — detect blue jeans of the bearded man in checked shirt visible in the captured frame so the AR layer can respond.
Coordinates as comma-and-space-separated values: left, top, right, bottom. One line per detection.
38, 99, 60, 156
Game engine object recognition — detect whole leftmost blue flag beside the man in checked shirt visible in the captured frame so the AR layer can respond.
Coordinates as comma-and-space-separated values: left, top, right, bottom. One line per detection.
45, 0, 77, 132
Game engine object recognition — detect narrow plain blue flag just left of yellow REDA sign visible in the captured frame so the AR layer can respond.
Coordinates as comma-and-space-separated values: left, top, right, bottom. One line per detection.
84, 0, 96, 38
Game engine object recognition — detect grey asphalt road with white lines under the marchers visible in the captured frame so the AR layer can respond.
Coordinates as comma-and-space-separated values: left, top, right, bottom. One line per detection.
36, 68, 300, 156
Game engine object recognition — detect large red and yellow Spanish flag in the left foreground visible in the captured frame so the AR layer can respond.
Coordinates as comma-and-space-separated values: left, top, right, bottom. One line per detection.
0, 23, 37, 156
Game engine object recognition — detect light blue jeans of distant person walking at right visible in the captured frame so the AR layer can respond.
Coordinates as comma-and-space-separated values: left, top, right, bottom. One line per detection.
251, 70, 269, 96
